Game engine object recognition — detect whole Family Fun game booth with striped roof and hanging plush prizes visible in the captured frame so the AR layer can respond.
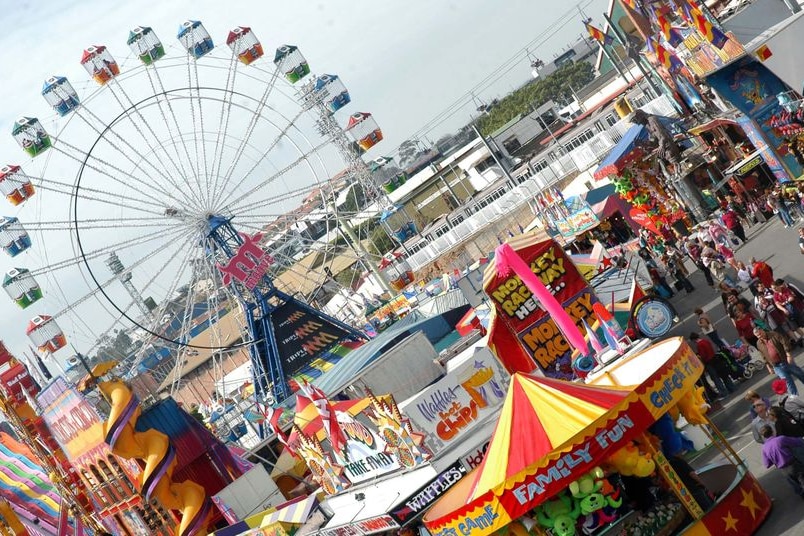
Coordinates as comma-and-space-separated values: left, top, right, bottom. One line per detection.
424, 338, 771, 536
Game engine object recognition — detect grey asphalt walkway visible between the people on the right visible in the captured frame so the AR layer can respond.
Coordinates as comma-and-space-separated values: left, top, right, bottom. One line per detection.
670, 217, 804, 536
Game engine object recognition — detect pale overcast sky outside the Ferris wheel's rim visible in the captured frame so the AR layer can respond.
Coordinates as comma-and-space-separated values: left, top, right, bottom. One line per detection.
0, 0, 607, 368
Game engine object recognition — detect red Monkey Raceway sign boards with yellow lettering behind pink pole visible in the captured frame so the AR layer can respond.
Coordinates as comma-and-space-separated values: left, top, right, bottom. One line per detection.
484, 236, 598, 379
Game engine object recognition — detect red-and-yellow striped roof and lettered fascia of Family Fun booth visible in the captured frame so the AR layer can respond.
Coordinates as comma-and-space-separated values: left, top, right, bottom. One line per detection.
424, 339, 703, 536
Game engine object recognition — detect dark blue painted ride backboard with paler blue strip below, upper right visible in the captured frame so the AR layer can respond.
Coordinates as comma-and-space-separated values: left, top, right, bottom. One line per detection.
706, 56, 804, 182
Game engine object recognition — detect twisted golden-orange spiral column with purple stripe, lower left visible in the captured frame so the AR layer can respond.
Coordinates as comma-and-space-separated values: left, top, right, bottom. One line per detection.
98, 379, 210, 536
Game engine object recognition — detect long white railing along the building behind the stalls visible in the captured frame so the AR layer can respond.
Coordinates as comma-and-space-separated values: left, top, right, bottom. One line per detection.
408, 95, 678, 270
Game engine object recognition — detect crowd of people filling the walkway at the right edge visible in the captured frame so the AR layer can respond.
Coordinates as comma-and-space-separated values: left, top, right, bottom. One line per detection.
652, 186, 804, 499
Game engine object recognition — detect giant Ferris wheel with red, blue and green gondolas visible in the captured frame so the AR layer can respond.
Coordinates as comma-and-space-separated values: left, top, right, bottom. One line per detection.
0, 21, 398, 406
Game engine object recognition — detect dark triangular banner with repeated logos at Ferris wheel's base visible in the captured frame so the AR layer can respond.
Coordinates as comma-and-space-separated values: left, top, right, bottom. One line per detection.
271, 302, 349, 376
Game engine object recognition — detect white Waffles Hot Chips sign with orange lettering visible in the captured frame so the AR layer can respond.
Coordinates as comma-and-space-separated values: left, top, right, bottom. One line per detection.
403, 348, 509, 453
